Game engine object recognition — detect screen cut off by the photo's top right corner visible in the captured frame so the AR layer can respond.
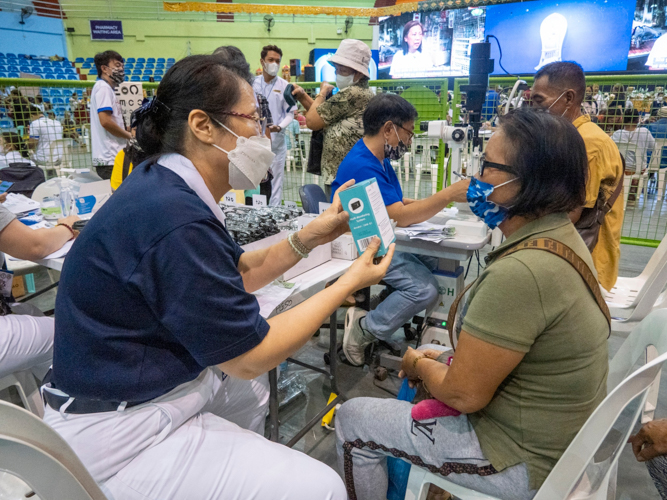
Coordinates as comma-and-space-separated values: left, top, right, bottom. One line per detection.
628, 0, 667, 71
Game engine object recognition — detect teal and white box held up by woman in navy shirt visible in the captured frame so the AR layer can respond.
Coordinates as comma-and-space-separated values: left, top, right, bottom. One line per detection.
339, 177, 396, 257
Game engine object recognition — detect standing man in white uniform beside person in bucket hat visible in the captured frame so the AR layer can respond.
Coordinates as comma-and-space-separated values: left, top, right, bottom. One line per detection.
252, 45, 296, 206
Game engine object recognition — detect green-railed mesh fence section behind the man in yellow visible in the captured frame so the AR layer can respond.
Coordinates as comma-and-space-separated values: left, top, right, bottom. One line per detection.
453, 75, 667, 246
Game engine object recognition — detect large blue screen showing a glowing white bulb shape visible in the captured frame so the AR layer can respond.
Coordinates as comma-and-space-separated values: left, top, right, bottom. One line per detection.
486, 0, 636, 75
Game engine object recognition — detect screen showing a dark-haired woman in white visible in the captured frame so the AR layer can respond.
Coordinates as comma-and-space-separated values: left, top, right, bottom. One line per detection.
378, 7, 486, 80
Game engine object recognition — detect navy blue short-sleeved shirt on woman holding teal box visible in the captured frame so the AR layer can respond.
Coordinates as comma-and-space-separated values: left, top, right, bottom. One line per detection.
53, 163, 269, 402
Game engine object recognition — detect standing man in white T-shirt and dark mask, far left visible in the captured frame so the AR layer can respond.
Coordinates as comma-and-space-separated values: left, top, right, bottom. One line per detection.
90, 50, 132, 179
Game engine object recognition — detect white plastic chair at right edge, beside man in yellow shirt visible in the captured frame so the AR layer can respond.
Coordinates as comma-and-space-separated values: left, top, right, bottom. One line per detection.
601, 232, 667, 333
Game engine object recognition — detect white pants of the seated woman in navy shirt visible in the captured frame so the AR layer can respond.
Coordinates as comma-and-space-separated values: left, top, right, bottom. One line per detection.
44, 369, 347, 500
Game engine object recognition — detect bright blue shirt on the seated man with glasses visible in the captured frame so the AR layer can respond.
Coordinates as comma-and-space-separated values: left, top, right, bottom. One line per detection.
331, 138, 403, 206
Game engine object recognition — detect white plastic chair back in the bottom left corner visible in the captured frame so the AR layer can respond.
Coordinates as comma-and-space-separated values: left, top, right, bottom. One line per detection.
0, 401, 107, 500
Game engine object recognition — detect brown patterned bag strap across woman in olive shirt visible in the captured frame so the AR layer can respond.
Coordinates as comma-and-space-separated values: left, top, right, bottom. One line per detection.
447, 238, 611, 348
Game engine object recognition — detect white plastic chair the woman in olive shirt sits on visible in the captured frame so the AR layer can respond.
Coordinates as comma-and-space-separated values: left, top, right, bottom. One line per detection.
405, 310, 667, 500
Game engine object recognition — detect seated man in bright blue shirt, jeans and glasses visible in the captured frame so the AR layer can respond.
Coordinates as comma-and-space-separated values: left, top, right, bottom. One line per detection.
331, 94, 468, 366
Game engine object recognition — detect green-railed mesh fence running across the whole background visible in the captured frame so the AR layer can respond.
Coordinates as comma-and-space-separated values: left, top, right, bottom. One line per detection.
5, 71, 667, 246
